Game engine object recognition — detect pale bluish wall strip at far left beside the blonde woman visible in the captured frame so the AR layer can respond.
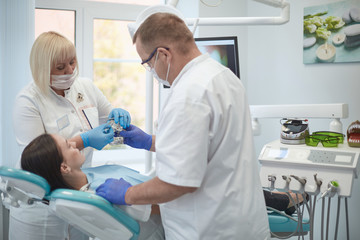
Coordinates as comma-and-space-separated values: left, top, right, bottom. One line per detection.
0, 0, 35, 166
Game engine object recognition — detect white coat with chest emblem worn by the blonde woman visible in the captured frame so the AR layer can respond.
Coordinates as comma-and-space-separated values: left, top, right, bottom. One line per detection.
9, 78, 112, 240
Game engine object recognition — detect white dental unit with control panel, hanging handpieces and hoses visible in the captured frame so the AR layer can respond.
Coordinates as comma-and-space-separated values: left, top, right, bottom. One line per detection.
250, 104, 360, 240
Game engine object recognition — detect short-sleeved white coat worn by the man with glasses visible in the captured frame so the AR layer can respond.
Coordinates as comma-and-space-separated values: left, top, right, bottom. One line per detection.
156, 55, 270, 240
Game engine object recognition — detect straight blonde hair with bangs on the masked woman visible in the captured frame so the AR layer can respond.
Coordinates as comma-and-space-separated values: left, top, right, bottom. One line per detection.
30, 31, 79, 95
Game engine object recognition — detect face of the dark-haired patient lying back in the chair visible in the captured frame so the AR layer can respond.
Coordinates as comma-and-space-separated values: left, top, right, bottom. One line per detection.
51, 134, 85, 169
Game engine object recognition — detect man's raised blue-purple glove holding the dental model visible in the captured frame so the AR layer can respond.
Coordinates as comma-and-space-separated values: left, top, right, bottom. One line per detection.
119, 124, 152, 150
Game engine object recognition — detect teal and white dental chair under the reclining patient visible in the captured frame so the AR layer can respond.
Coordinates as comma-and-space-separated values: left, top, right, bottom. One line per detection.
0, 166, 309, 240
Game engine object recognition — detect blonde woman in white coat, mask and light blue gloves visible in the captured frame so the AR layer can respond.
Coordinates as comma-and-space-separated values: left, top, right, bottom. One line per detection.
9, 32, 130, 240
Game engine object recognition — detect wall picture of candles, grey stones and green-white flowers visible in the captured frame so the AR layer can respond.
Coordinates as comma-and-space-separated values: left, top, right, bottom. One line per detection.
303, 0, 360, 64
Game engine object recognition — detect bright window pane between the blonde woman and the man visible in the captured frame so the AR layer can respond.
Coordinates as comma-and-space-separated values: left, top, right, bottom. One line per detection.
93, 19, 146, 129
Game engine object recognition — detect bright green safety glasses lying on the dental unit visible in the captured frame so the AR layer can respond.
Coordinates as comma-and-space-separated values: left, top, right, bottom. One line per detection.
305, 131, 345, 147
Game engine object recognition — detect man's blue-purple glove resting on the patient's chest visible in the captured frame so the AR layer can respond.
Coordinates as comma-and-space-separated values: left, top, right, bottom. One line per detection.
96, 178, 131, 205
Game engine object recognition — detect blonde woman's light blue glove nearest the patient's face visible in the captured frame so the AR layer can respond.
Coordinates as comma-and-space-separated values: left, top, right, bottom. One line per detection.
80, 124, 114, 150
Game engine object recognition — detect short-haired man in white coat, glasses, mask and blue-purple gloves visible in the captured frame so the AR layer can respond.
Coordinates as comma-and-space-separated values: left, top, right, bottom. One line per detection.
96, 9, 270, 240
